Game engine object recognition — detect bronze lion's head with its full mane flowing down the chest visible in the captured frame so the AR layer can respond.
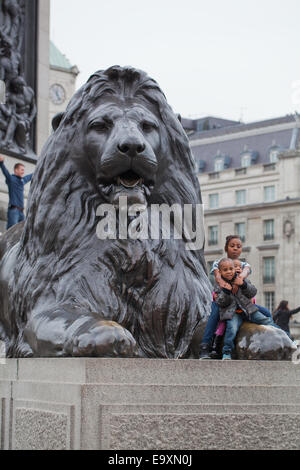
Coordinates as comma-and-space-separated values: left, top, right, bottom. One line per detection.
8, 66, 210, 357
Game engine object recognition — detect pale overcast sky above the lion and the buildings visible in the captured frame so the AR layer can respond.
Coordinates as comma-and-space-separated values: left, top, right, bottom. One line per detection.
50, 0, 300, 122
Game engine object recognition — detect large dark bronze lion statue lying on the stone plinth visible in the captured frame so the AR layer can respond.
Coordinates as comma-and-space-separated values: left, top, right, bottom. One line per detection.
0, 66, 211, 358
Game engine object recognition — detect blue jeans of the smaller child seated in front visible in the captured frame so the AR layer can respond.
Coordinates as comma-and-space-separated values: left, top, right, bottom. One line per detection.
223, 312, 278, 354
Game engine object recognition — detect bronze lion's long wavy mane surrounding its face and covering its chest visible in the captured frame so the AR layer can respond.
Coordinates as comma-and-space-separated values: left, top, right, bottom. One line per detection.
9, 66, 210, 357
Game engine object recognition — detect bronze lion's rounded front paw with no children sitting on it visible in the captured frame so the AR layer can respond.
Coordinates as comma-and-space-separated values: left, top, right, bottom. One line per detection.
65, 321, 137, 357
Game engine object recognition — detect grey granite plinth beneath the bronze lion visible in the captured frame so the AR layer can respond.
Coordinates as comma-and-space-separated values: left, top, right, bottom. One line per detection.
0, 358, 300, 450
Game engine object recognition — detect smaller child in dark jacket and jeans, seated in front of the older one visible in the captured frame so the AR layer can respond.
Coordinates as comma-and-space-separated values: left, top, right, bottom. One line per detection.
215, 258, 277, 360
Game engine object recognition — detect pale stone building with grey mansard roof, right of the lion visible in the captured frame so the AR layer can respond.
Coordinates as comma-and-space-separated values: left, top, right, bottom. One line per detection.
183, 115, 300, 320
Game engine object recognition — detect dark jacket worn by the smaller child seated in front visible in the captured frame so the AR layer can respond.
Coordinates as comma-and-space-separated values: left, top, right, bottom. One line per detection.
215, 280, 258, 320
